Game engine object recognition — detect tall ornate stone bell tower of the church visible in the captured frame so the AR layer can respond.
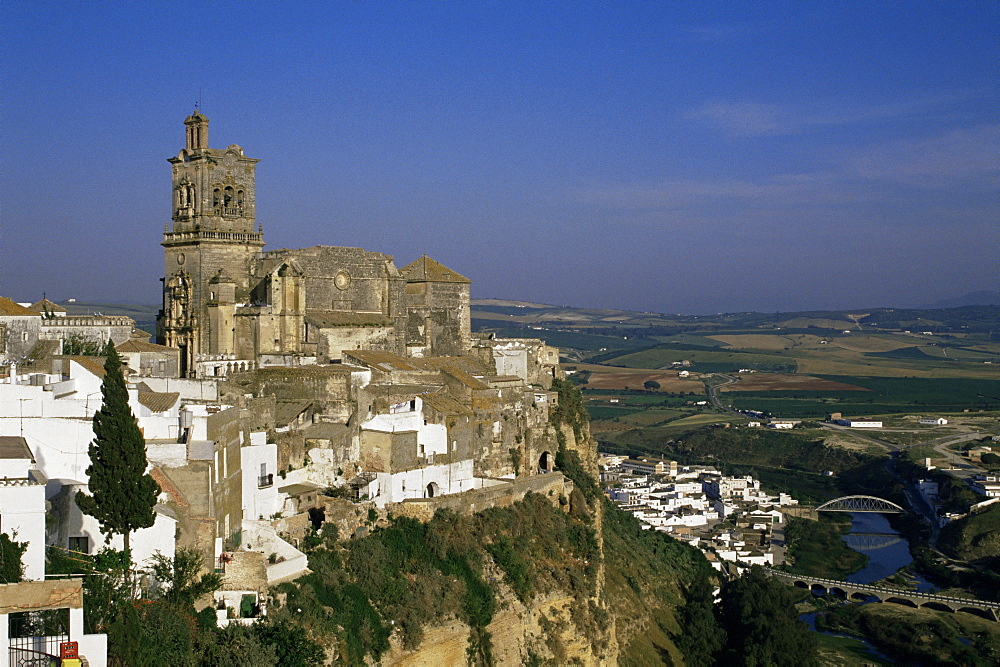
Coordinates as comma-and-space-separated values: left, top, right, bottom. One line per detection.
157, 108, 264, 375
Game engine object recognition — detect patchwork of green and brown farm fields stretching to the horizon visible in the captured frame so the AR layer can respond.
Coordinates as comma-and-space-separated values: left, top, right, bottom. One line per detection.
473, 302, 1000, 456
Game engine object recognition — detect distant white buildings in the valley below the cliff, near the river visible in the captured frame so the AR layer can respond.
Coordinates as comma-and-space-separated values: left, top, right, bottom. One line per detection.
601, 454, 798, 569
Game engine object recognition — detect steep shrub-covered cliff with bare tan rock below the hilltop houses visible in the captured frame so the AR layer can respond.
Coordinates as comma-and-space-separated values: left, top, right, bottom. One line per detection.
270, 378, 707, 665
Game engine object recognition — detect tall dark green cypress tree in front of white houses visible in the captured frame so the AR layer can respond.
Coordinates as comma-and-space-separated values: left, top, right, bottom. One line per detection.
76, 340, 160, 559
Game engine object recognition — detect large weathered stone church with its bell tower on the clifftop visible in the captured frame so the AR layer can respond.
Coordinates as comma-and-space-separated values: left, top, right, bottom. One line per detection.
157, 109, 471, 376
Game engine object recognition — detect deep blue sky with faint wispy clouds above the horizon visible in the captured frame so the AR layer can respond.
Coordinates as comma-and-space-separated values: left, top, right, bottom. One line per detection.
0, 0, 1000, 313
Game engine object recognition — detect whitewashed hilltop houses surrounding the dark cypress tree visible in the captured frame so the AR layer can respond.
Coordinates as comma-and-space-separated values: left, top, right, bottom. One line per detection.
0, 357, 296, 665
